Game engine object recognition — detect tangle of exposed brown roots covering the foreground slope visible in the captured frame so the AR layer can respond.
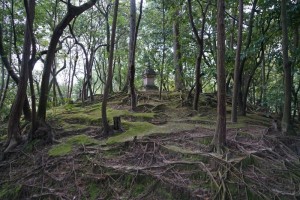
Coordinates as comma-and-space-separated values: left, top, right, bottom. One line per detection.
0, 125, 300, 199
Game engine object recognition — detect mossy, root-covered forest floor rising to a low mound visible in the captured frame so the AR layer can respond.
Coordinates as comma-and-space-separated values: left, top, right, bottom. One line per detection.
0, 92, 300, 200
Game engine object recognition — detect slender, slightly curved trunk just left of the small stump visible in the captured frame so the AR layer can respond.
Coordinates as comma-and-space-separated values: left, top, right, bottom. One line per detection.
101, 0, 119, 136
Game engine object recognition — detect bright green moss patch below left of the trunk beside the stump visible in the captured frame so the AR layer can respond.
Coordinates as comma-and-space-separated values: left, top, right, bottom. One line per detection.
48, 135, 99, 156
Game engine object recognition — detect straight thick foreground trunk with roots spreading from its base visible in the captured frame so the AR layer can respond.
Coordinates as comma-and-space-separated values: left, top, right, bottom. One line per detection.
214, 0, 226, 153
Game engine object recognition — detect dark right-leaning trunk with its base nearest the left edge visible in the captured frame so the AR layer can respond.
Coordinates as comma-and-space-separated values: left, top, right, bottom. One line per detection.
5, 0, 35, 152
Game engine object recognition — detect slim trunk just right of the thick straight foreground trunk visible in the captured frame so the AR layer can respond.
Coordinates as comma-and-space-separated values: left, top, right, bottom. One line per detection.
231, 0, 244, 122
